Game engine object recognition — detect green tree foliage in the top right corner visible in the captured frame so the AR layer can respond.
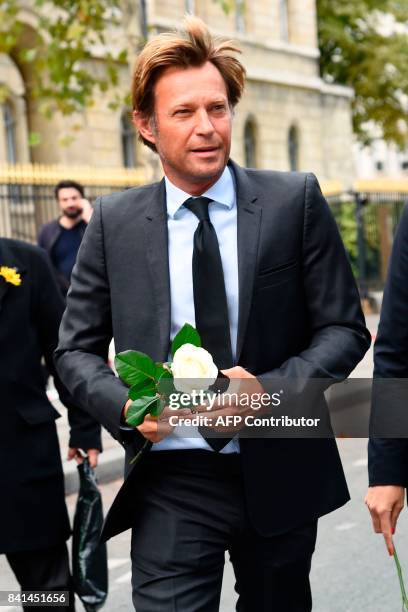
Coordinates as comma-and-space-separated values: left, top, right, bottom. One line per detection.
317, 0, 408, 148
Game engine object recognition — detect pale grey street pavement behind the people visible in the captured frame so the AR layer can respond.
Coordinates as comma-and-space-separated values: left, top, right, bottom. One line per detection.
0, 315, 408, 612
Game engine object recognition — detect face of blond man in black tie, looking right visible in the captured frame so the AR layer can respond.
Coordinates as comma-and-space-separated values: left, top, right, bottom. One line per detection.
134, 62, 232, 195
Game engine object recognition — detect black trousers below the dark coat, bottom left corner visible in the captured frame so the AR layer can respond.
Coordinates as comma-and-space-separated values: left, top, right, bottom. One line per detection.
6, 542, 75, 612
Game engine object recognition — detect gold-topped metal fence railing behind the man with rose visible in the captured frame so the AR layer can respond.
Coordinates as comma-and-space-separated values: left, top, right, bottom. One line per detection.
0, 164, 408, 297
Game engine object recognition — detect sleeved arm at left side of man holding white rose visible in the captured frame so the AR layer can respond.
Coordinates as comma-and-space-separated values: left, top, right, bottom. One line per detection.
55, 199, 142, 443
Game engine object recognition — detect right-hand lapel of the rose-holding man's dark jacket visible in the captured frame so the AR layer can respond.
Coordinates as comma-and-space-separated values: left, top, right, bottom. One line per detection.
230, 162, 262, 363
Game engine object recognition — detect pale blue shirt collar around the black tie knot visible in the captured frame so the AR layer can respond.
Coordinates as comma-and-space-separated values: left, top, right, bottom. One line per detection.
164, 166, 235, 219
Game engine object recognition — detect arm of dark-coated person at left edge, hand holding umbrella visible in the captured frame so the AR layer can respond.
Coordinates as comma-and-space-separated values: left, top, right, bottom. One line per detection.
34, 251, 102, 466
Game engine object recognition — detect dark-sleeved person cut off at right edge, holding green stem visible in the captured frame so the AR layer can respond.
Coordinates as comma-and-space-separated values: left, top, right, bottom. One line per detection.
365, 206, 408, 555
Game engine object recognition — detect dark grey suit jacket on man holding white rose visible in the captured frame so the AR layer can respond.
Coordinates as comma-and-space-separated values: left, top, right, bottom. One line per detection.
56, 162, 370, 537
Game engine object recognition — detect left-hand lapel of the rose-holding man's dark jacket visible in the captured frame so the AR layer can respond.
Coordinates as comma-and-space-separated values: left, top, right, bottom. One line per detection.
144, 180, 170, 361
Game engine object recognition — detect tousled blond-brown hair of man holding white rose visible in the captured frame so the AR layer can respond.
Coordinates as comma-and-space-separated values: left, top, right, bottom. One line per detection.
132, 16, 245, 150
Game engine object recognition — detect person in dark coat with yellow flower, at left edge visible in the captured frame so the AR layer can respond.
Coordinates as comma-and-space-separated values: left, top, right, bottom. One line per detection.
0, 238, 101, 610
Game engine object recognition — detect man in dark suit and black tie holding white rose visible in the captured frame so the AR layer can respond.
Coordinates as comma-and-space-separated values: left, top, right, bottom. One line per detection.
56, 18, 369, 612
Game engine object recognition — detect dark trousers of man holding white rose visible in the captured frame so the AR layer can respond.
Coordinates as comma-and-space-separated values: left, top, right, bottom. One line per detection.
131, 450, 317, 612
